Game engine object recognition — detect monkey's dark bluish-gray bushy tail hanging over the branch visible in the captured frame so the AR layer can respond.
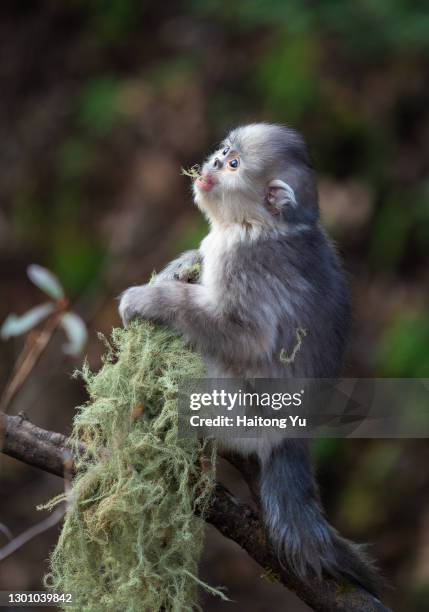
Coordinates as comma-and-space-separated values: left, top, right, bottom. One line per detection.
260, 440, 382, 596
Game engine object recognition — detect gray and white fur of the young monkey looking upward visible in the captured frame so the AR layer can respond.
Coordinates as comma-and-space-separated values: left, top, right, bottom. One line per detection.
119, 124, 376, 592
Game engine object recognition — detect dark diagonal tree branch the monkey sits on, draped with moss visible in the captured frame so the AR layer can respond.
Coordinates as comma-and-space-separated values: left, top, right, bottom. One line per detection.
0, 414, 389, 612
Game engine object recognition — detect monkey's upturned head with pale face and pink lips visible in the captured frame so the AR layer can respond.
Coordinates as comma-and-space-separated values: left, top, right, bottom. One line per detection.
194, 123, 319, 227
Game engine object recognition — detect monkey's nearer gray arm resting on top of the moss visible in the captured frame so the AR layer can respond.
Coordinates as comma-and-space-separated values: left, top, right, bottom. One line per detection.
119, 281, 275, 361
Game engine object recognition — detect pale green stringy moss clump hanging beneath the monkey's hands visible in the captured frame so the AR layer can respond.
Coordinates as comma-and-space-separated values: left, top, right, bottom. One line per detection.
46, 322, 222, 612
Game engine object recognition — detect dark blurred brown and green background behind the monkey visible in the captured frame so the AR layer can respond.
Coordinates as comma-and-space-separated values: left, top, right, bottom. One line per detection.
0, 0, 429, 612
